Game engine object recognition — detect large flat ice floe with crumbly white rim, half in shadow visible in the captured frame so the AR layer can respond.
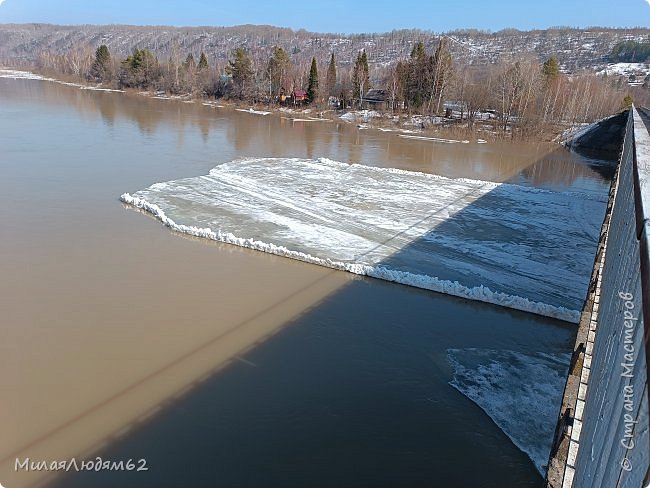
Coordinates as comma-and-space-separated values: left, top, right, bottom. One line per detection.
122, 158, 605, 322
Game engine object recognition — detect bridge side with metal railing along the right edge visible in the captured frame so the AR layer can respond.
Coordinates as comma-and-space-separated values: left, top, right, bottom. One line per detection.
546, 107, 650, 488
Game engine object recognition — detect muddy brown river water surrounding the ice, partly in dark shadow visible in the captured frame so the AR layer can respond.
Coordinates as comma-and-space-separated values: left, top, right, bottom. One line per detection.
0, 79, 607, 488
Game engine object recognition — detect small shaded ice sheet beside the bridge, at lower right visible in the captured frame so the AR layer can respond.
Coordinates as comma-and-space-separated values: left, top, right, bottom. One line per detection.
447, 349, 571, 476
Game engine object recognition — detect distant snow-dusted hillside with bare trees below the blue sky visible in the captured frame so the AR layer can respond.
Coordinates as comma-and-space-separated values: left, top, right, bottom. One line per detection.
0, 24, 650, 72
